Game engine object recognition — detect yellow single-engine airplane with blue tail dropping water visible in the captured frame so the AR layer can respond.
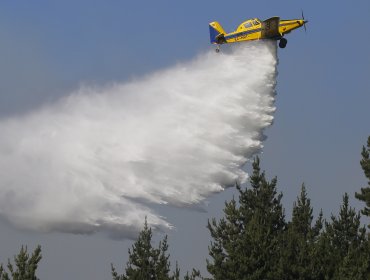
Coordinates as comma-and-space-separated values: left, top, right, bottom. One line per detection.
209, 11, 308, 52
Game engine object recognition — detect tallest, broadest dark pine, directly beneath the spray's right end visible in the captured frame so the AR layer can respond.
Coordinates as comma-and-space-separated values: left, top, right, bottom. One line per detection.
207, 157, 285, 280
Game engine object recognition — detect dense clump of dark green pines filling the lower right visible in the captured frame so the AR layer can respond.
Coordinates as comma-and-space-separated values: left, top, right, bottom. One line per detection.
207, 156, 370, 280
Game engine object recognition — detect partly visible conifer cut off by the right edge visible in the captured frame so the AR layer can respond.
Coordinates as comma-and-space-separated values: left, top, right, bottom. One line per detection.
355, 136, 370, 223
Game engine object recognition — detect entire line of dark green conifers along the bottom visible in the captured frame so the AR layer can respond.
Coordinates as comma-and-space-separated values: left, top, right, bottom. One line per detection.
0, 136, 370, 280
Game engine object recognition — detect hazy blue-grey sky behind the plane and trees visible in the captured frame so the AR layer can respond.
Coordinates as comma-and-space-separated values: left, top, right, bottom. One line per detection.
0, 0, 370, 280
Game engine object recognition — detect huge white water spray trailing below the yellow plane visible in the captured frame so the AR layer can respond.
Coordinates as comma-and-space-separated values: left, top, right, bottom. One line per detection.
0, 41, 277, 237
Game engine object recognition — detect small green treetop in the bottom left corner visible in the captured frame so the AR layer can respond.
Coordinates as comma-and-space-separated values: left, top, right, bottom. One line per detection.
0, 246, 42, 280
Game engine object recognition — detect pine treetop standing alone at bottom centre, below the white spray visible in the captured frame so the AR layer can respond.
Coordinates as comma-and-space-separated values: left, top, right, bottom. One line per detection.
111, 219, 179, 280
